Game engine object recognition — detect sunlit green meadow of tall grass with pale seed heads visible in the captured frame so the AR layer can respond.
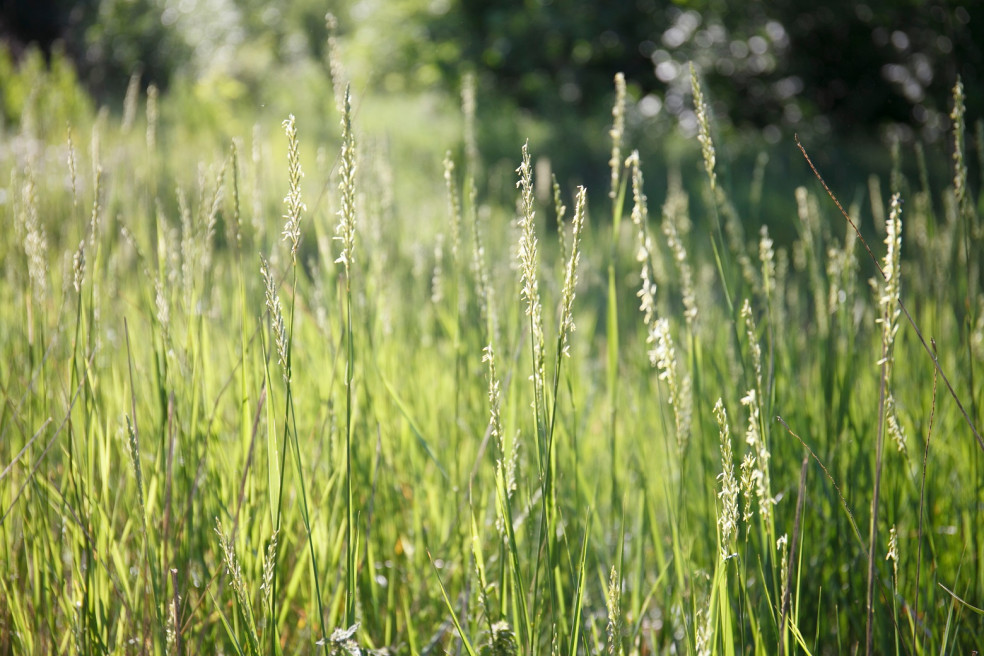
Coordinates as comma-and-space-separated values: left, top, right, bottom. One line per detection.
0, 59, 984, 655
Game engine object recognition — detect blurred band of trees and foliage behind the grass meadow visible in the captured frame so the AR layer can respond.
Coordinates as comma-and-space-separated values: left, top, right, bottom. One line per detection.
0, 0, 984, 208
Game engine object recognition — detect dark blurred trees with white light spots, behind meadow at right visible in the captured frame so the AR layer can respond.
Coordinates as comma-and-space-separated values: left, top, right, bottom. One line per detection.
423, 0, 984, 144
